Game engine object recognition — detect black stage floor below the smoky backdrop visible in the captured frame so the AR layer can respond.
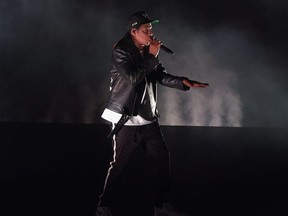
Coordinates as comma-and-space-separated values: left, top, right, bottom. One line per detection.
0, 122, 288, 216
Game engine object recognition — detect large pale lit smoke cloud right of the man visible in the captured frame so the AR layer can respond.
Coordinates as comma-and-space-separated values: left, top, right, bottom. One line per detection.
155, 20, 288, 127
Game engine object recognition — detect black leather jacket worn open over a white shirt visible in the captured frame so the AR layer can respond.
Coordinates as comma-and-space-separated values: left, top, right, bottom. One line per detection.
106, 33, 189, 116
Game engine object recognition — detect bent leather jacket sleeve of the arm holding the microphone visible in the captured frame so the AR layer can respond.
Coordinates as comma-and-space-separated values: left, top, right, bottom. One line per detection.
112, 49, 159, 86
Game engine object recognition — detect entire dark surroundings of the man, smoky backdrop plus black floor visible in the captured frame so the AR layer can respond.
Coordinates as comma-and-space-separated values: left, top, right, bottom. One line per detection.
0, 0, 288, 216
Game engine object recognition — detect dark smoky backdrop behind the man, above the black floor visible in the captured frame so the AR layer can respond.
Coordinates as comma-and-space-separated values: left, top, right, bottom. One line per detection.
0, 0, 288, 127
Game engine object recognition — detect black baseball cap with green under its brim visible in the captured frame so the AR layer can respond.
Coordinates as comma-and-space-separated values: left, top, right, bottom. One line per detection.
127, 11, 159, 30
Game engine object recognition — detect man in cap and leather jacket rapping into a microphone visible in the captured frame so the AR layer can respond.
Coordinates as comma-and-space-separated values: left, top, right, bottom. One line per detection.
96, 11, 208, 216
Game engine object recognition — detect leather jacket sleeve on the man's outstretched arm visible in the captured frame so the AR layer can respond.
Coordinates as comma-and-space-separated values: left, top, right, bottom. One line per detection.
153, 64, 190, 91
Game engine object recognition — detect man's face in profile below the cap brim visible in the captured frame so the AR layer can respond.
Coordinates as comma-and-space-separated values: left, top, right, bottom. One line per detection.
132, 23, 153, 46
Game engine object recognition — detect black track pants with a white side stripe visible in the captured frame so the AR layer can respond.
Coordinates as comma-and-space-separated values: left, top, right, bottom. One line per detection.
100, 122, 170, 206
